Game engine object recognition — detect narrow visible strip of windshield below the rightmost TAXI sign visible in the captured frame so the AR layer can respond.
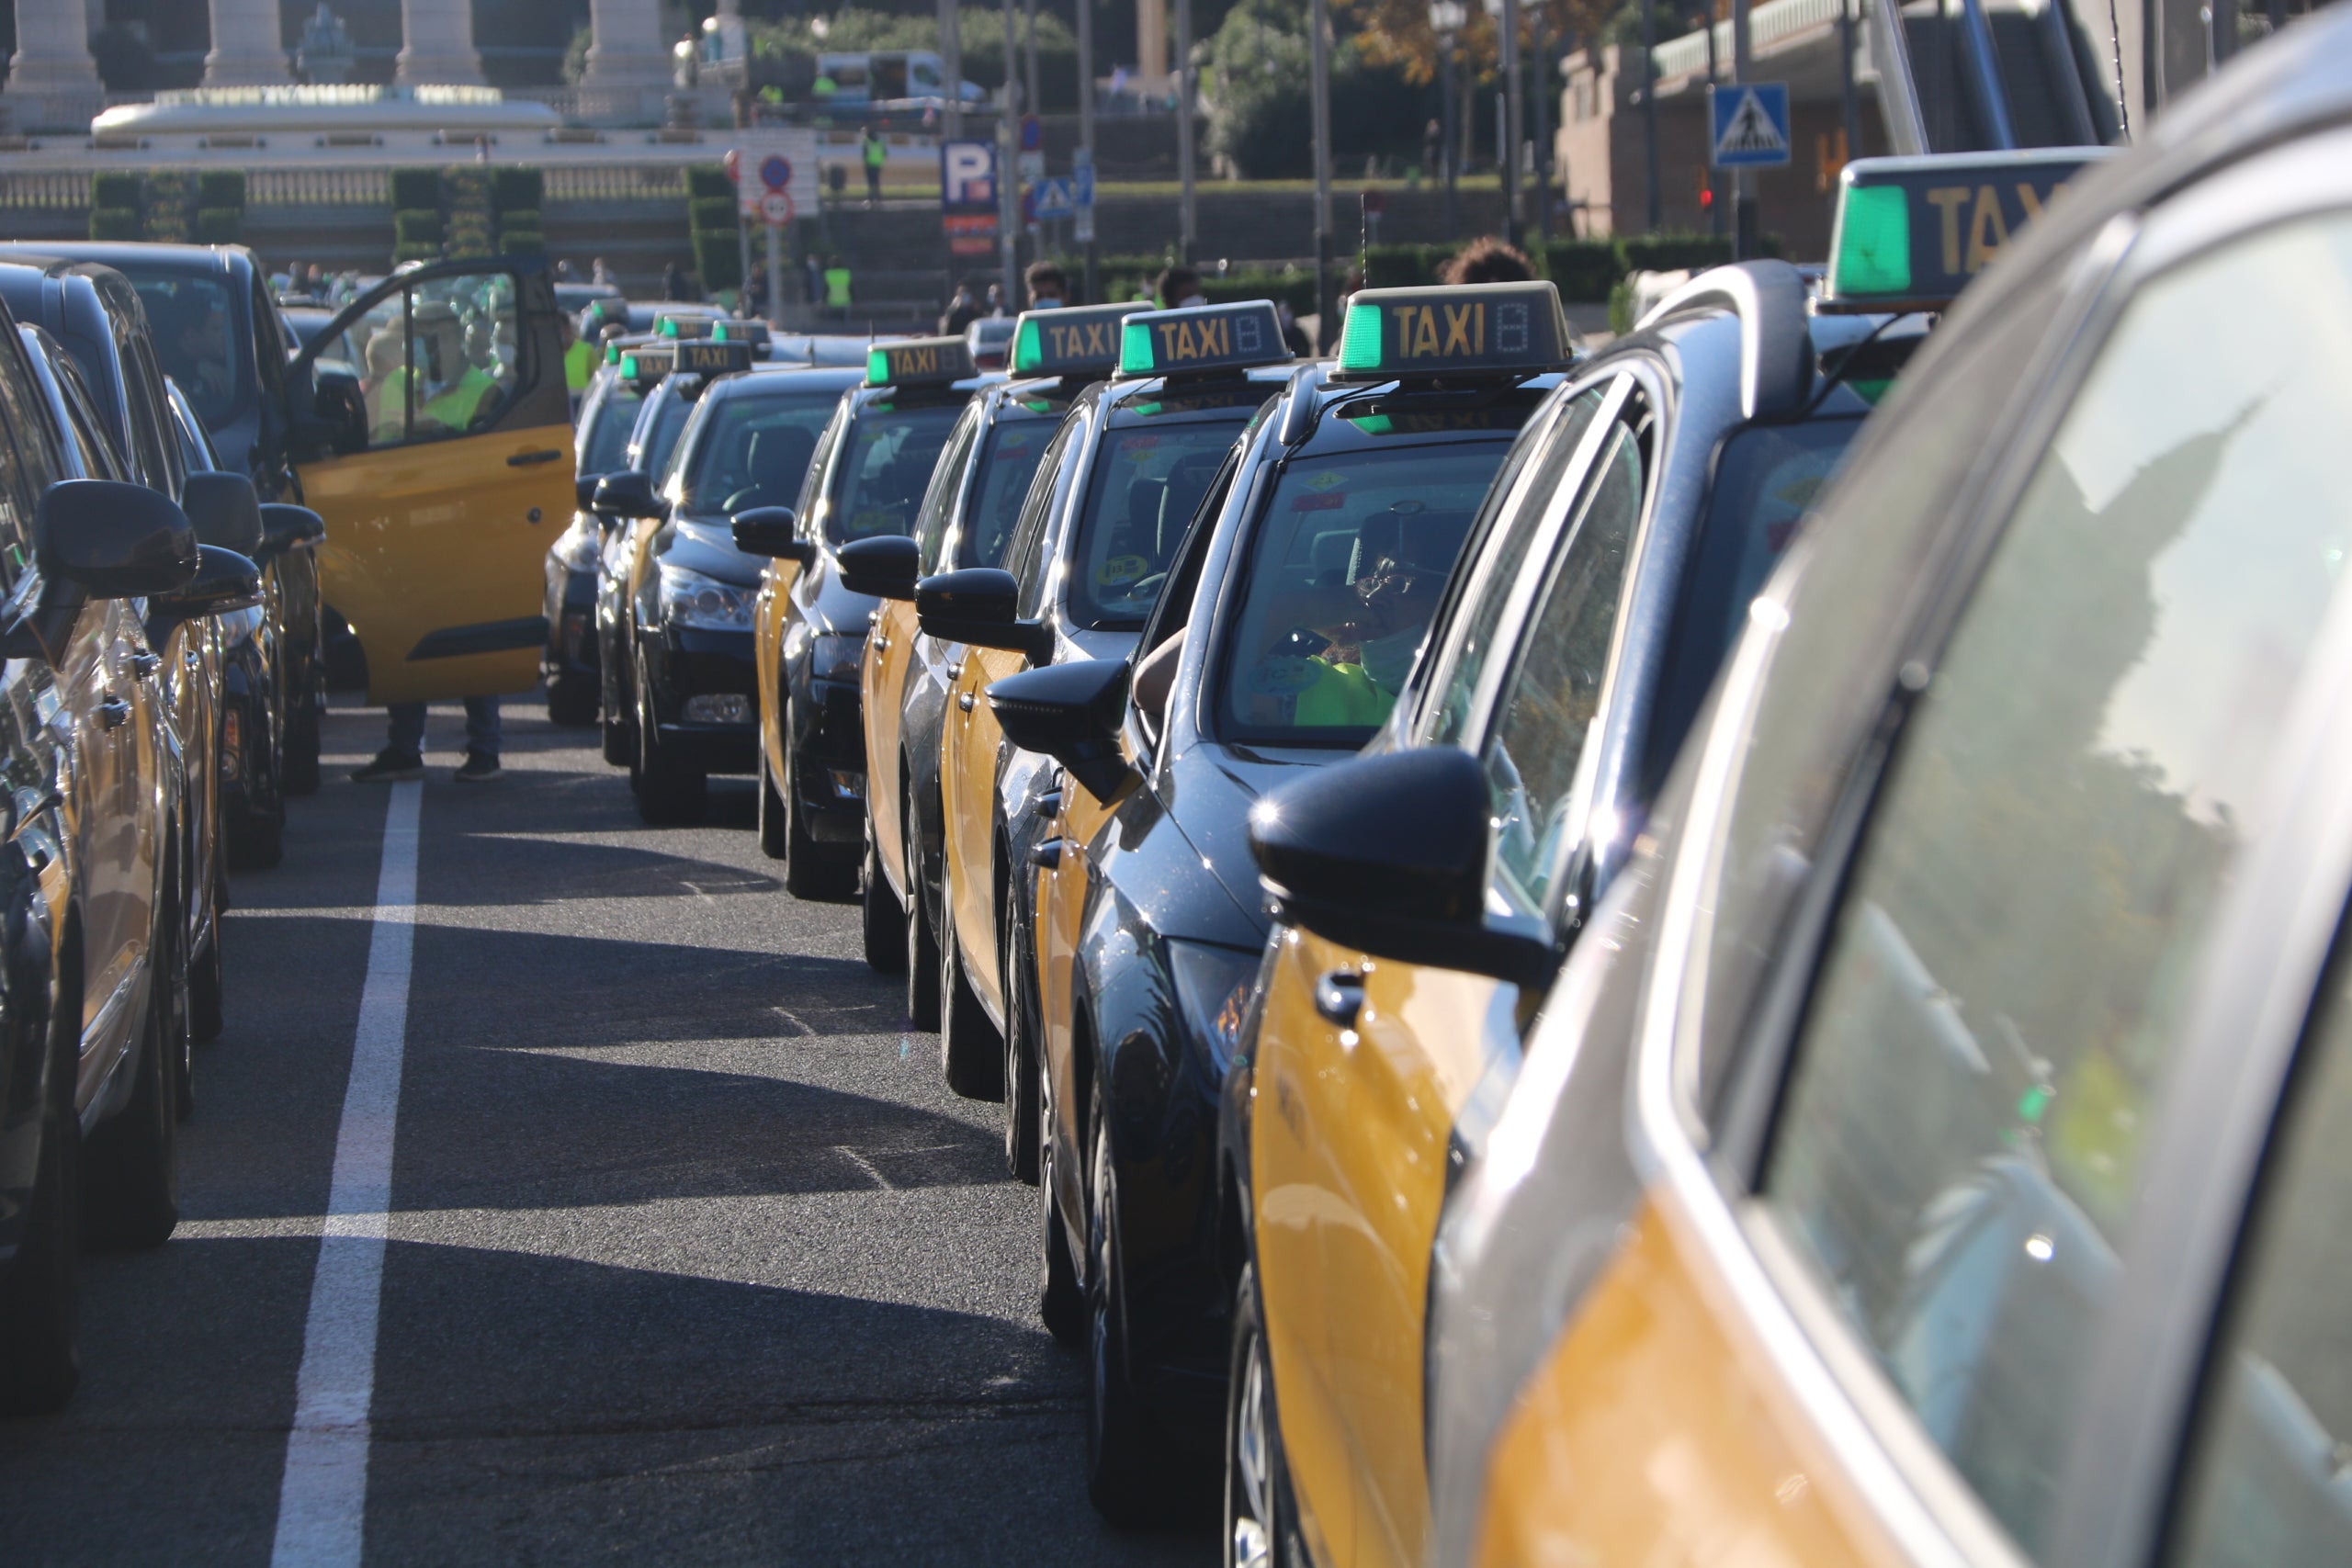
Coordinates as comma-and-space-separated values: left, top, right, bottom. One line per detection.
1642, 419, 1863, 795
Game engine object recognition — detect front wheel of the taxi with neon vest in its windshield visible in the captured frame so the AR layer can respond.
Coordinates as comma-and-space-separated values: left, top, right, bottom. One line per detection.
1087, 1075, 1171, 1526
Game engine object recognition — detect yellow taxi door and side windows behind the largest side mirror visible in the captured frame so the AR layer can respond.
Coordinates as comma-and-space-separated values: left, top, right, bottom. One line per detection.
1251, 376, 1654, 1565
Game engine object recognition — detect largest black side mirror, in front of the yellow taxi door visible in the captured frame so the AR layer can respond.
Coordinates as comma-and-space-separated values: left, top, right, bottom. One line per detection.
1249, 745, 1555, 987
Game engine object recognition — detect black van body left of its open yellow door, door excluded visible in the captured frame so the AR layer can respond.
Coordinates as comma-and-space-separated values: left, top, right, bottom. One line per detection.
0, 240, 329, 795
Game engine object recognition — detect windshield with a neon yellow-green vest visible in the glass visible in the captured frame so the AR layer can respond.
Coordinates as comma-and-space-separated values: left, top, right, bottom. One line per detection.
1218, 440, 1510, 745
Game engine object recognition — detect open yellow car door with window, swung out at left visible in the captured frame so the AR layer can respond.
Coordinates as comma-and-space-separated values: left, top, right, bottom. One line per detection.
291, 256, 574, 703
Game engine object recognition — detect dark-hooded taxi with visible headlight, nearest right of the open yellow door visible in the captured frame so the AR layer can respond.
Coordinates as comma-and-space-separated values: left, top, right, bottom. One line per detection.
621, 339, 858, 823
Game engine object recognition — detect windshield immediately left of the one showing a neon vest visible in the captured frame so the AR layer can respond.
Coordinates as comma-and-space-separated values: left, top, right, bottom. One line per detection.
1070, 423, 1256, 632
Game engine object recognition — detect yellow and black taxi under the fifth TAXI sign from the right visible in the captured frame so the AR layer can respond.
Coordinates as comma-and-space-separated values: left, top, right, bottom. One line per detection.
736, 339, 1002, 898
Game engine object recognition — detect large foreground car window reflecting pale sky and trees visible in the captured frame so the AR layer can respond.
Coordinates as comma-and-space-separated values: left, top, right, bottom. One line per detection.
1761, 219, 2352, 1554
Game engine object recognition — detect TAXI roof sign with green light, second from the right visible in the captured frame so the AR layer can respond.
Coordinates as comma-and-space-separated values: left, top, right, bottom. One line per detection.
1331, 282, 1574, 381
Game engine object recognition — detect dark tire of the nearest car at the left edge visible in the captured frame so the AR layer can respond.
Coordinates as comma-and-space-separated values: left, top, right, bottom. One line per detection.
0, 999, 83, 1416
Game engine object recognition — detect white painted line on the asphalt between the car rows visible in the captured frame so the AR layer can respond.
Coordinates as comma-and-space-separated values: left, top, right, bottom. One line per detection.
270, 781, 424, 1568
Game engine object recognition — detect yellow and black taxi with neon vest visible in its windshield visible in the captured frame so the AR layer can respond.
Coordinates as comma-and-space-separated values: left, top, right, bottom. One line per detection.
988, 282, 1574, 1518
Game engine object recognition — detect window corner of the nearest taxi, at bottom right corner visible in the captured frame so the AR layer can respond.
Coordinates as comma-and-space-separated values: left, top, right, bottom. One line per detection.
2168, 926, 2352, 1568
